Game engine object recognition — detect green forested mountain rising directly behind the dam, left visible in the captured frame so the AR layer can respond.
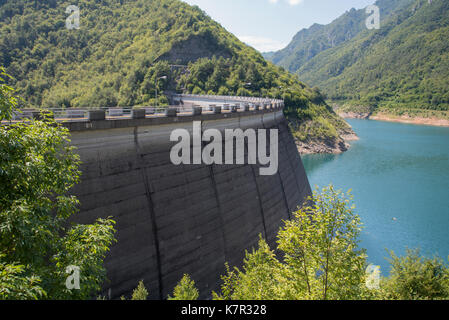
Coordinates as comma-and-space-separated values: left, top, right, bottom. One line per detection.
0, 0, 347, 150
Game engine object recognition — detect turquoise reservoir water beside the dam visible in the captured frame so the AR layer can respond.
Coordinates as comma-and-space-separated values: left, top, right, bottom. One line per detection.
303, 120, 449, 274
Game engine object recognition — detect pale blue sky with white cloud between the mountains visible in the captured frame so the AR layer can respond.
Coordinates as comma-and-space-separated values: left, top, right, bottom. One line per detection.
184, 0, 375, 51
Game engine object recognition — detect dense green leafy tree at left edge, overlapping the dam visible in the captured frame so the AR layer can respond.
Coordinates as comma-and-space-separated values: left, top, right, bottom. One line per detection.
0, 69, 114, 300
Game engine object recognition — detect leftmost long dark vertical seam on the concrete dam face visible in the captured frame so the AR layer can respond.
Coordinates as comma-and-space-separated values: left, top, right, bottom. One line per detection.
134, 127, 163, 300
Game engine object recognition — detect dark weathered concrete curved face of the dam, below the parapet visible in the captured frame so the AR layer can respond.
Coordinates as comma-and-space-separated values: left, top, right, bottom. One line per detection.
64, 110, 311, 299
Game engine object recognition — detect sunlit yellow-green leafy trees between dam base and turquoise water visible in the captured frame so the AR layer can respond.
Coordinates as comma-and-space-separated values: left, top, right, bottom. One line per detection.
214, 187, 369, 300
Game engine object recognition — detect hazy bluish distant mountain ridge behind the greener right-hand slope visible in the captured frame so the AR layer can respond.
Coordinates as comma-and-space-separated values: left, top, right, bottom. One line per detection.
264, 0, 415, 72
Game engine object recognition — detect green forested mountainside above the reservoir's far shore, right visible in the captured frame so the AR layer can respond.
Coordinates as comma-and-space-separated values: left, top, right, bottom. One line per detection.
264, 0, 449, 117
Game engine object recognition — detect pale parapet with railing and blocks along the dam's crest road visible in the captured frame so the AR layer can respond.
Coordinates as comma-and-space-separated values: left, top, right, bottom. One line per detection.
8, 94, 284, 122
